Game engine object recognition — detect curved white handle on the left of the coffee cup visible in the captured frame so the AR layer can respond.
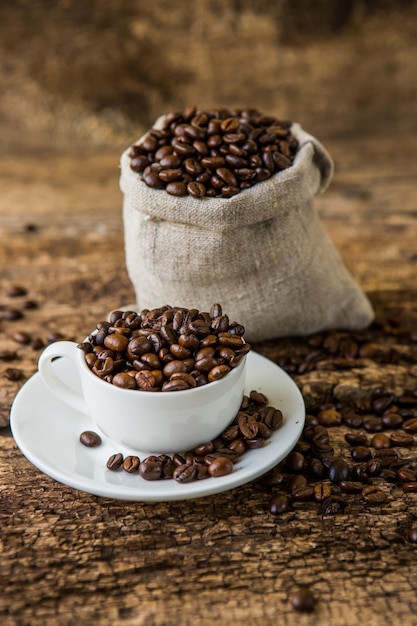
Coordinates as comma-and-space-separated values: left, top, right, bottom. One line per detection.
38, 341, 88, 414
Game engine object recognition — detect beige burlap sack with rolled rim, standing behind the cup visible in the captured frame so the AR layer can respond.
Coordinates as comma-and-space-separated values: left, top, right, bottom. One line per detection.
120, 120, 373, 342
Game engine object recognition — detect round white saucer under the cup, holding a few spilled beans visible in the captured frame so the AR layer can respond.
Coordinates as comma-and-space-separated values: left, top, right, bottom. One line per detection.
10, 352, 305, 502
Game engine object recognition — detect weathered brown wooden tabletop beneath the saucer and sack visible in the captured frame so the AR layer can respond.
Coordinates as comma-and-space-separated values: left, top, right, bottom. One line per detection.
0, 136, 417, 626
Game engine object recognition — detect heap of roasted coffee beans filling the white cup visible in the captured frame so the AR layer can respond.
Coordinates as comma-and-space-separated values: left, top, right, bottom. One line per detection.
78, 304, 250, 392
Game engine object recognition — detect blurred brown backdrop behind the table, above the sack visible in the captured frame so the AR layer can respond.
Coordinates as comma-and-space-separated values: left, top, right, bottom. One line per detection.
0, 0, 417, 158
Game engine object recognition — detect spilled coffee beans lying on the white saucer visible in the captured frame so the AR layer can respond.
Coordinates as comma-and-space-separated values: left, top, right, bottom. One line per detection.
80, 390, 284, 484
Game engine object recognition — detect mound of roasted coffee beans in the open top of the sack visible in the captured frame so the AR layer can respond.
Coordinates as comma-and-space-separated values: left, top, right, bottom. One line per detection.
129, 106, 298, 198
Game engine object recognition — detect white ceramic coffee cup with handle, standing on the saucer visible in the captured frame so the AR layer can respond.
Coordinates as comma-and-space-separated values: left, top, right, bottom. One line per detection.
39, 341, 246, 454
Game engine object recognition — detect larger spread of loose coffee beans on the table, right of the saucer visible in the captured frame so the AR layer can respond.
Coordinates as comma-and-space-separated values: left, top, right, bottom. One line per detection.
259, 387, 417, 515
